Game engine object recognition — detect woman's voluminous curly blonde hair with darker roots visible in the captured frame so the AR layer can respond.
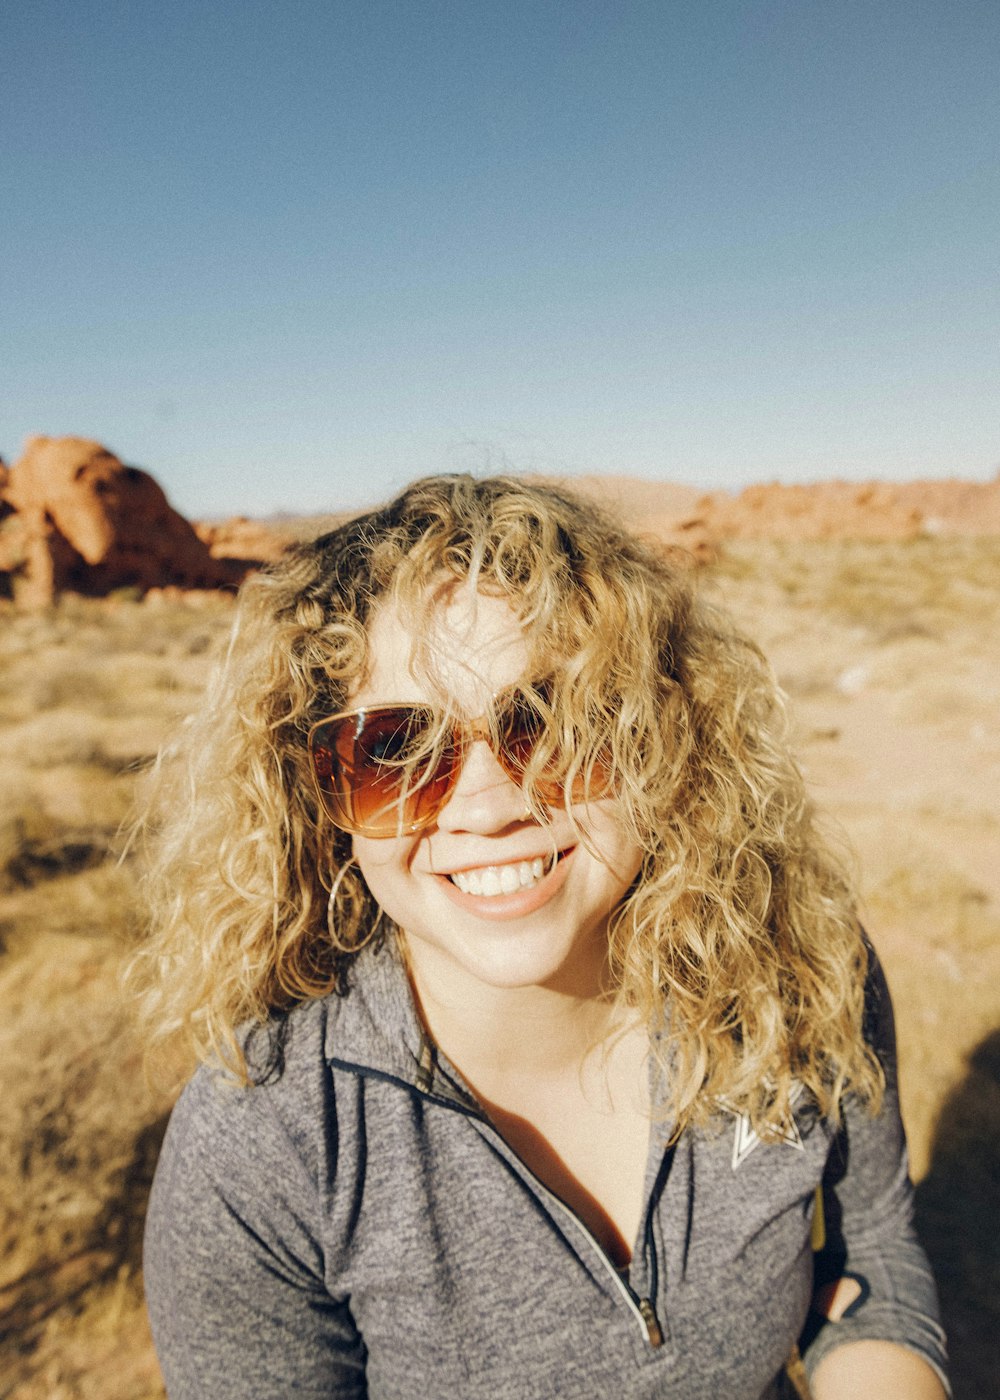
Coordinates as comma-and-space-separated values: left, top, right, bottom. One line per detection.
132, 476, 881, 1135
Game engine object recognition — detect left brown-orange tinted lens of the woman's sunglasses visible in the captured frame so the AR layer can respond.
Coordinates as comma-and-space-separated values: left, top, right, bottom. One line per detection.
312, 706, 455, 837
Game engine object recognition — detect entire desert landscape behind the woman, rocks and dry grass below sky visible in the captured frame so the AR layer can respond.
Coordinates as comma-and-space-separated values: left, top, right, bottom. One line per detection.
0, 438, 1000, 1400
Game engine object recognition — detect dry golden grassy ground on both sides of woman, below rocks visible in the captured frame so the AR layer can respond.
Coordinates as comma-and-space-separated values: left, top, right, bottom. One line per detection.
0, 538, 1000, 1400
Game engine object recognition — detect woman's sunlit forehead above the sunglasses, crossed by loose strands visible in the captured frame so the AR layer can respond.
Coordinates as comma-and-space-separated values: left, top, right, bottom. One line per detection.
354, 585, 528, 715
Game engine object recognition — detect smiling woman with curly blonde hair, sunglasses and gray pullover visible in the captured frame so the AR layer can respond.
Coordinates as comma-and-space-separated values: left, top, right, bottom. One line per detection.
140, 476, 944, 1400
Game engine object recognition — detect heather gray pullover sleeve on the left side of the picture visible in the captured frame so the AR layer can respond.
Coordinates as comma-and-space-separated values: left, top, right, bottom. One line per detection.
143, 1071, 367, 1400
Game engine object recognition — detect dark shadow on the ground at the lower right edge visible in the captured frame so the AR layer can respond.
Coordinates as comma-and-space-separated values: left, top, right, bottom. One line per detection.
916, 1029, 1000, 1400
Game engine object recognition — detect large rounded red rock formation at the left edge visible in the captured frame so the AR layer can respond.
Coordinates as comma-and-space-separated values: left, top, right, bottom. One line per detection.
0, 437, 264, 606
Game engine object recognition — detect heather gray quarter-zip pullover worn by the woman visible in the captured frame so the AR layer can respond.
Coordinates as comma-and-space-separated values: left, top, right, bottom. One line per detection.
146, 944, 947, 1400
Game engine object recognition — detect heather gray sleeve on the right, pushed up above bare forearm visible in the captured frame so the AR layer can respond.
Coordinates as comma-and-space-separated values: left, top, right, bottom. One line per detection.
801, 948, 951, 1393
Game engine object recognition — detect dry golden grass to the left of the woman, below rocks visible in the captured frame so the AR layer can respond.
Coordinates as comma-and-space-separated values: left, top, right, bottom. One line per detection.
0, 601, 230, 1400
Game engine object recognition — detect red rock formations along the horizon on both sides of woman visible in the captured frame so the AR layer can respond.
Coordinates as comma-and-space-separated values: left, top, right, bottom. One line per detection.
0, 437, 1000, 608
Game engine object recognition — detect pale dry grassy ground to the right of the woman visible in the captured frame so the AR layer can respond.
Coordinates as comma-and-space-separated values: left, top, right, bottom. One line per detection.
714, 538, 1000, 1400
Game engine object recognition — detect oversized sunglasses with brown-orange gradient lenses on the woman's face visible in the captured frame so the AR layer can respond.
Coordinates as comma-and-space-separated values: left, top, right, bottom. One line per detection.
308, 689, 602, 837
